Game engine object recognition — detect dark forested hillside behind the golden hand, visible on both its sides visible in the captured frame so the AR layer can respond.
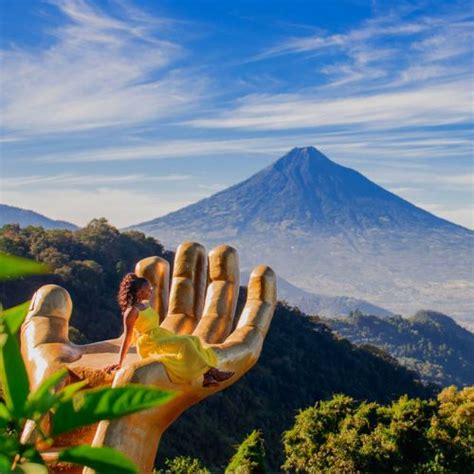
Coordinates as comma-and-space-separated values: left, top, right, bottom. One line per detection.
0, 220, 432, 470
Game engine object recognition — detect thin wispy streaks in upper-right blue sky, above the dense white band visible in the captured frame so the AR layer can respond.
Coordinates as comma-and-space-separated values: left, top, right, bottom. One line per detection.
250, 7, 474, 92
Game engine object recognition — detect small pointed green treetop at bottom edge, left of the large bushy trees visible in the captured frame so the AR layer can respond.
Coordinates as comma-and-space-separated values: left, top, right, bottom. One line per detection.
225, 430, 270, 474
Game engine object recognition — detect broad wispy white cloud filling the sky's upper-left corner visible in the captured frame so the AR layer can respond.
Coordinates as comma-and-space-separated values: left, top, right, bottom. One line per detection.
0, 0, 204, 134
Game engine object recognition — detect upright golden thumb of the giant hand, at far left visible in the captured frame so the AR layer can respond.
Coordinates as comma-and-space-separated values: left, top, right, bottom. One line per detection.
20, 285, 81, 389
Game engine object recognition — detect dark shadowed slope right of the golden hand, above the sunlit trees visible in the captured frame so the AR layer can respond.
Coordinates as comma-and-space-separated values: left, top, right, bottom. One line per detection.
158, 304, 433, 472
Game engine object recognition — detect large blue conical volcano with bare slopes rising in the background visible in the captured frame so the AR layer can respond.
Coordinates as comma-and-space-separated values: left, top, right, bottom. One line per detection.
131, 147, 474, 321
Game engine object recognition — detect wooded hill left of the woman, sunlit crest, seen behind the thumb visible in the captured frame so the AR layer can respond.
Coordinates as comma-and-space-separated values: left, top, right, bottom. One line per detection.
0, 219, 172, 342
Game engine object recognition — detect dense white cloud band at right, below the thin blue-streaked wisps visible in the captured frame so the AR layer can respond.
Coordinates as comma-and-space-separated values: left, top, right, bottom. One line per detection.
187, 81, 472, 130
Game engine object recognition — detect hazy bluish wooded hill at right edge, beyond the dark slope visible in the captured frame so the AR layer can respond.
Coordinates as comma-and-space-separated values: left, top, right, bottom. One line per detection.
324, 311, 474, 387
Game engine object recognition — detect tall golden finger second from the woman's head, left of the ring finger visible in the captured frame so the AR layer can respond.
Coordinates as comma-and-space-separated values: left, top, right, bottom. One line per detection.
161, 242, 207, 334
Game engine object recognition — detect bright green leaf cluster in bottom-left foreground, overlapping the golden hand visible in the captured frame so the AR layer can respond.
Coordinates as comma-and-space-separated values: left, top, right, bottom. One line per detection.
0, 255, 173, 473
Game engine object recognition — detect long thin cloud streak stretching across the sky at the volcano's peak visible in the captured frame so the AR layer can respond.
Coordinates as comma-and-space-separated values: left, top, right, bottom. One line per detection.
28, 127, 472, 169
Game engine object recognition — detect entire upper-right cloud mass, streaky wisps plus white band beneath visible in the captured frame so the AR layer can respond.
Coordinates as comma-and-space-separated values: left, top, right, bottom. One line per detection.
186, 8, 474, 132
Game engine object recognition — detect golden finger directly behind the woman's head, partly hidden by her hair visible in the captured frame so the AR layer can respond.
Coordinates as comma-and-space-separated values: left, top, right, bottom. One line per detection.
135, 257, 170, 323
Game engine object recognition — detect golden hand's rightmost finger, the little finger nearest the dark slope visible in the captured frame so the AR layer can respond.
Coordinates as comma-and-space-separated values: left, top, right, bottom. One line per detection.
212, 265, 277, 377
